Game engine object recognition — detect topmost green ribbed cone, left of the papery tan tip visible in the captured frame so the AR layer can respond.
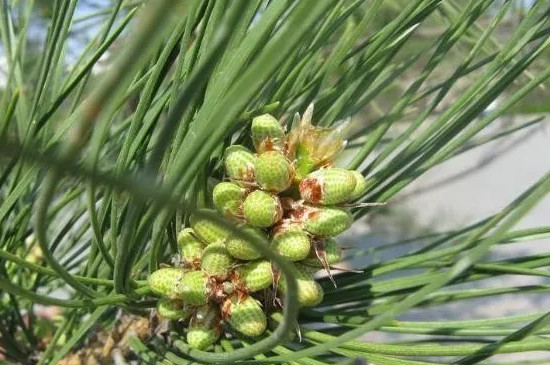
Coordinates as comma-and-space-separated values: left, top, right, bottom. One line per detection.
250, 114, 285, 153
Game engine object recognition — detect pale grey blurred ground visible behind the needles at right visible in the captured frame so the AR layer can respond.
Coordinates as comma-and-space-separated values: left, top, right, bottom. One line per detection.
342, 116, 550, 364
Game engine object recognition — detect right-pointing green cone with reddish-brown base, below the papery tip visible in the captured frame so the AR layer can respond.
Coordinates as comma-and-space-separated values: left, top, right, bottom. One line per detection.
300, 168, 356, 205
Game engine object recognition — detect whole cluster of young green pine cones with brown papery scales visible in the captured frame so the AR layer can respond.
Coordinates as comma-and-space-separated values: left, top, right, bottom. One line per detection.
149, 107, 367, 350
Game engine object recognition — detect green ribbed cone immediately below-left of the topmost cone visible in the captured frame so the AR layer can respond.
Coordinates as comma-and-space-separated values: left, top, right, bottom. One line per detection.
224, 145, 256, 186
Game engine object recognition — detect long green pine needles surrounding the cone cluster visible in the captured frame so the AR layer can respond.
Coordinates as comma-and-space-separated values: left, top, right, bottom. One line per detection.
0, 0, 550, 365
